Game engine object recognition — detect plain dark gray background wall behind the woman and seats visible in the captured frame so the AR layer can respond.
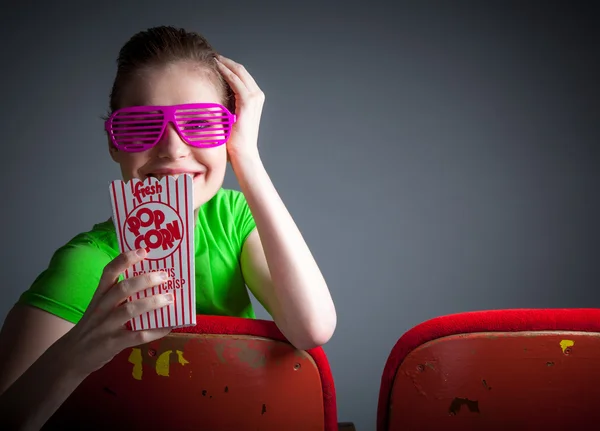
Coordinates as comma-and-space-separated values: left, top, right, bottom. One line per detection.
0, 0, 600, 430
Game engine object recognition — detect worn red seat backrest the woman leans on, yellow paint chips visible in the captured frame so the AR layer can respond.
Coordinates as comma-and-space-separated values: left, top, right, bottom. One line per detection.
45, 316, 337, 431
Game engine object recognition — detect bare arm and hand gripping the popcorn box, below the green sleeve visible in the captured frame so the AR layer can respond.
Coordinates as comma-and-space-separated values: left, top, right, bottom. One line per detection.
0, 250, 173, 430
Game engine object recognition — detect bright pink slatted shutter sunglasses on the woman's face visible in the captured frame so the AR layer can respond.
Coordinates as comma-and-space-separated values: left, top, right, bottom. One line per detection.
104, 103, 236, 153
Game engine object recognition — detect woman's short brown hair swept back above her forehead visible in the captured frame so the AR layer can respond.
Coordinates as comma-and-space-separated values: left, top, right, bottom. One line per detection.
110, 26, 235, 112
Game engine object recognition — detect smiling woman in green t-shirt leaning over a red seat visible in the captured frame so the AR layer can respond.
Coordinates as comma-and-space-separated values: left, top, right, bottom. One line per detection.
0, 27, 336, 429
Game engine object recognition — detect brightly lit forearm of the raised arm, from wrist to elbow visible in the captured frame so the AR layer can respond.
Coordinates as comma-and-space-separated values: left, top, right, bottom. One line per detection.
231, 155, 336, 345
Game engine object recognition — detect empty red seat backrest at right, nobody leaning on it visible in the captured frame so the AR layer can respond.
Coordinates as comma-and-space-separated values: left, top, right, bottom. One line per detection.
377, 309, 600, 431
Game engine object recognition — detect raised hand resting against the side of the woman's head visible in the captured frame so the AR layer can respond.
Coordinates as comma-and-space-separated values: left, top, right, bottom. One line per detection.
216, 55, 265, 160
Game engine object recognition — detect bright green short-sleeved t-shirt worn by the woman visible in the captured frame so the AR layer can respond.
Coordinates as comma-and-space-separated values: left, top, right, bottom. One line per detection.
18, 189, 256, 323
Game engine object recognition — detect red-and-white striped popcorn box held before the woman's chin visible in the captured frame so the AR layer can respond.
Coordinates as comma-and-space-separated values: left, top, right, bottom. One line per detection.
110, 174, 196, 331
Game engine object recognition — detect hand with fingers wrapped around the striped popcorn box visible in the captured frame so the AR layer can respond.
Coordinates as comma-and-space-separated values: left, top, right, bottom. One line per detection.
59, 249, 173, 375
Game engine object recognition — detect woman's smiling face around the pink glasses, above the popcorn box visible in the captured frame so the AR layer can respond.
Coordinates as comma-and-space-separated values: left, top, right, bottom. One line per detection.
109, 63, 227, 210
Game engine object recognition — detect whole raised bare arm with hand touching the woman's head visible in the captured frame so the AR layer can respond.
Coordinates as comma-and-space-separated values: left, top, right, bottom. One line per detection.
216, 56, 336, 349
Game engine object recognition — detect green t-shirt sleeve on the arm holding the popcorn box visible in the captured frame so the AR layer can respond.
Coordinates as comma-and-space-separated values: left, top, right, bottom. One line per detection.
18, 236, 112, 323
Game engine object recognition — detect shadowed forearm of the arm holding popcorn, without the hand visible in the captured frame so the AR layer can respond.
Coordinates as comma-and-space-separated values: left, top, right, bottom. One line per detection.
0, 340, 85, 430
